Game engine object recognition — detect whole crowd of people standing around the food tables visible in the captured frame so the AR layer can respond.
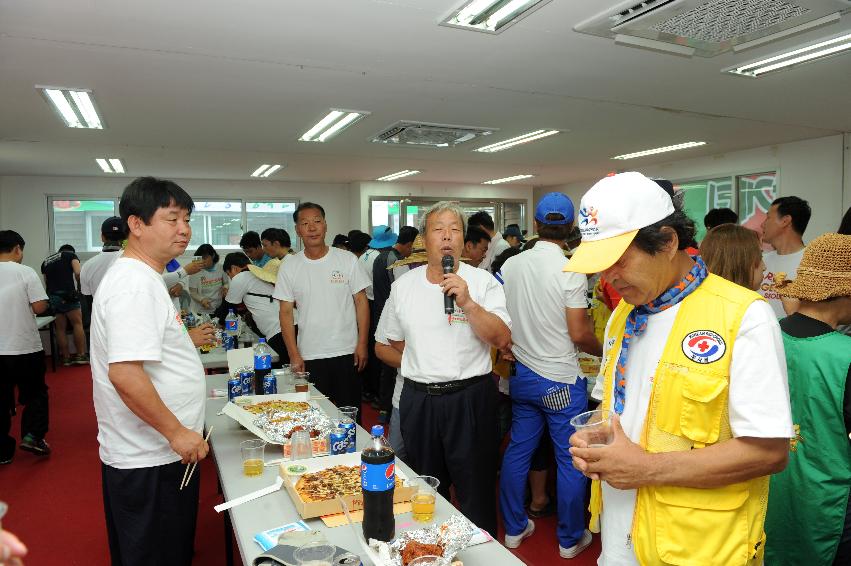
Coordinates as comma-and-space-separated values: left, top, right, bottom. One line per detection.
0, 172, 851, 566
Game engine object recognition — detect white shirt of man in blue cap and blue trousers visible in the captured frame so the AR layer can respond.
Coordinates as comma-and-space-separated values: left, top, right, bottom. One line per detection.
502, 242, 588, 384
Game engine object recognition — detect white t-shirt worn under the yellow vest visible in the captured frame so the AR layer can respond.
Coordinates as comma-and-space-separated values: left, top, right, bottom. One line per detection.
588, 300, 794, 566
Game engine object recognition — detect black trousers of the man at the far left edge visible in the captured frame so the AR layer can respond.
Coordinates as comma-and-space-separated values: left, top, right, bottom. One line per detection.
0, 350, 50, 459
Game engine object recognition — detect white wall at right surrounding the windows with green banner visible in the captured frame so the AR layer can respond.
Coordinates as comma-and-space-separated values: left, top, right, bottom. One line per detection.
534, 134, 851, 241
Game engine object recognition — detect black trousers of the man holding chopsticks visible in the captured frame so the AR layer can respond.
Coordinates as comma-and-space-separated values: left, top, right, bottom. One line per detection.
101, 462, 201, 566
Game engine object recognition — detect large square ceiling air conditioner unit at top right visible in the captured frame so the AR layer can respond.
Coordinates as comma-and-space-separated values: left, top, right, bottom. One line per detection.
573, 0, 851, 57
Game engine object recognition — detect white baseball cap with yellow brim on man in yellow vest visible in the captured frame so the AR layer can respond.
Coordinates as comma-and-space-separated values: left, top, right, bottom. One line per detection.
564, 171, 674, 273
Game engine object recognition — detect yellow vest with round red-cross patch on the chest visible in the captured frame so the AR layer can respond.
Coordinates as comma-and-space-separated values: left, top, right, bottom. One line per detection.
590, 274, 768, 566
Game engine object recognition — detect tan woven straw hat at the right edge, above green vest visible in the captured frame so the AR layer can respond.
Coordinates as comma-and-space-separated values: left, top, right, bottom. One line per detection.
775, 234, 851, 302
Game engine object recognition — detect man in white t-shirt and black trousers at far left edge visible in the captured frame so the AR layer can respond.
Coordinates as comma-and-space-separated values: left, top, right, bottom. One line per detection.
0, 230, 50, 464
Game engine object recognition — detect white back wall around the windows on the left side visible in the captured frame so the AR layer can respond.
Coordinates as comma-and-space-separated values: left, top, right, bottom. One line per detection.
0, 177, 352, 270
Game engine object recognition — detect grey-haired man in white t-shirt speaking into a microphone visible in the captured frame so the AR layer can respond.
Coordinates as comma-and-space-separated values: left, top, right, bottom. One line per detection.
375, 201, 511, 535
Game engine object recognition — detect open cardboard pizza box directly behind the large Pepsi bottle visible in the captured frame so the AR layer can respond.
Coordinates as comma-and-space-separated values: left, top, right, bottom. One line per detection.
279, 452, 417, 519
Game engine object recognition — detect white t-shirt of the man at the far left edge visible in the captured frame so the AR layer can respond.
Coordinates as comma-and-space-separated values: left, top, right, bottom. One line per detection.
0, 261, 47, 356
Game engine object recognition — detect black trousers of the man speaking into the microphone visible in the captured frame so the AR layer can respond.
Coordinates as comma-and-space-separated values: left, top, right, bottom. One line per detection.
399, 378, 499, 537
